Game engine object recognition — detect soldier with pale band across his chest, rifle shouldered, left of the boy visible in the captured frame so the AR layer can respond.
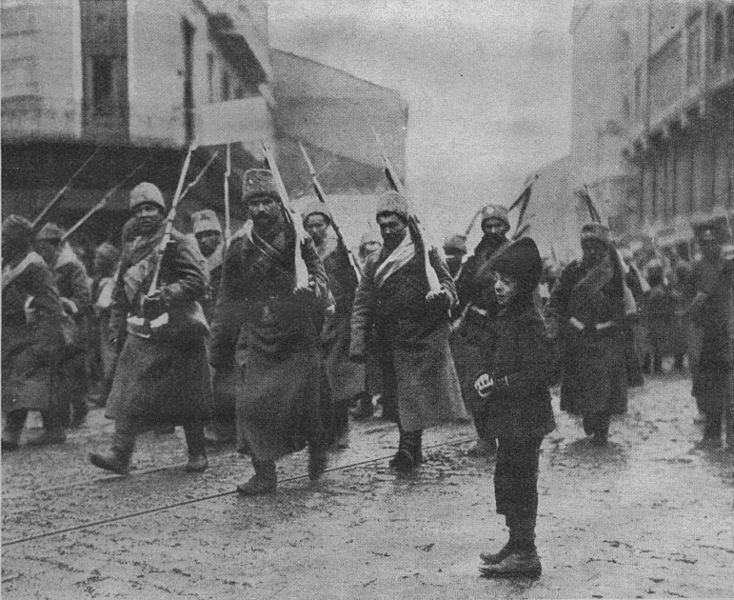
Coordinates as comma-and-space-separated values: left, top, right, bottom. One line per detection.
350, 192, 466, 474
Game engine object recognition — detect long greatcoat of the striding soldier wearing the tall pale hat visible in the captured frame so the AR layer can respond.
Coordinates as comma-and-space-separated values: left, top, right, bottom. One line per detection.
106, 228, 212, 428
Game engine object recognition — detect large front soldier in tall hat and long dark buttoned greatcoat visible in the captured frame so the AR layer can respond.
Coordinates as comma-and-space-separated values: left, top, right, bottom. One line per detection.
211, 169, 329, 496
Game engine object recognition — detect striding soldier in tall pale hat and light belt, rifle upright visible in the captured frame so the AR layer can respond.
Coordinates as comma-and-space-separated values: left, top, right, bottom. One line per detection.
90, 182, 211, 474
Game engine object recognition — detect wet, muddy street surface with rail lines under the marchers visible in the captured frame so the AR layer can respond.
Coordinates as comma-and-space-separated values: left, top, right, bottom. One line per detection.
2, 376, 734, 600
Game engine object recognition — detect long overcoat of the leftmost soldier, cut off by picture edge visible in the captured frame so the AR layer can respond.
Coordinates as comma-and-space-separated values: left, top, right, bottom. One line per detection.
2, 252, 64, 412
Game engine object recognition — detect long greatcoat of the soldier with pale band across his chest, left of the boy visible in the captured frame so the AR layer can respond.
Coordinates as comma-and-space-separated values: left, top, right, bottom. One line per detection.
350, 240, 467, 431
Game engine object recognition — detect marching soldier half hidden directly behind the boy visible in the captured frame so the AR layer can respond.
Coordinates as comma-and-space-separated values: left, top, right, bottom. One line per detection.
454, 204, 510, 457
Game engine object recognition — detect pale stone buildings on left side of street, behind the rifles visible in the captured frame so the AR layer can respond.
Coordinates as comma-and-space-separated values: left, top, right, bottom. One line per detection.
2, 0, 407, 244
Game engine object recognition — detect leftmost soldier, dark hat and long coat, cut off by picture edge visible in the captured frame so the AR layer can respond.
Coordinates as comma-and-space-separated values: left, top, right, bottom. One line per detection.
2, 215, 66, 451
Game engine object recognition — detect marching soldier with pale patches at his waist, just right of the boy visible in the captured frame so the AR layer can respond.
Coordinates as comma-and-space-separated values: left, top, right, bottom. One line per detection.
546, 223, 627, 446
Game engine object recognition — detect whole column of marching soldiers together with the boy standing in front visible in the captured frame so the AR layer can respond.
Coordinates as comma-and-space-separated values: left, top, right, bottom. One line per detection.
2, 169, 734, 577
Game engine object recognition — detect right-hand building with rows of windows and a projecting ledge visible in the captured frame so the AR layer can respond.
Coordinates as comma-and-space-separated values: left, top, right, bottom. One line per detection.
625, 0, 734, 255
